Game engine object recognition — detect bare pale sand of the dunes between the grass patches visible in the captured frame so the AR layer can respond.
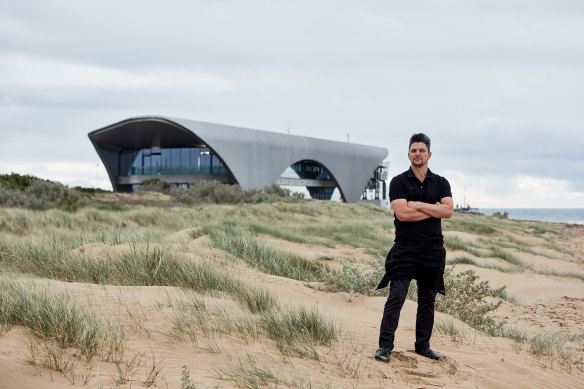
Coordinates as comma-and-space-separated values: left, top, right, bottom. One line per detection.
0, 209, 584, 389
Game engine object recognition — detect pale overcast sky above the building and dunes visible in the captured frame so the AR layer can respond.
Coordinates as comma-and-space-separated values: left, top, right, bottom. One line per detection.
0, 0, 584, 208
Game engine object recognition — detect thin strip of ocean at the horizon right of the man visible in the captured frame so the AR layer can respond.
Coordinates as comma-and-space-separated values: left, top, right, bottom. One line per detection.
479, 208, 584, 224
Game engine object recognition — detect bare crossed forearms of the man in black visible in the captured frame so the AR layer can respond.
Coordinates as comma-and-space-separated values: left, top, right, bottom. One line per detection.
391, 197, 454, 222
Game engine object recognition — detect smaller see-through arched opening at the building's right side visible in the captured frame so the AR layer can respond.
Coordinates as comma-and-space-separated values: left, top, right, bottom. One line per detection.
276, 159, 344, 201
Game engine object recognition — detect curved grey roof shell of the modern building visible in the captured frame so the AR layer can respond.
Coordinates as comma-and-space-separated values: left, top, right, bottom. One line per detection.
89, 116, 388, 202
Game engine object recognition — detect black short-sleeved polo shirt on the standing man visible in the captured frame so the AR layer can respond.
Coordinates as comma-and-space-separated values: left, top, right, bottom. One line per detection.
389, 168, 452, 248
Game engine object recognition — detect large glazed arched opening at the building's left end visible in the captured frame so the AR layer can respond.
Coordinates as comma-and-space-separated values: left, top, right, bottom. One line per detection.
90, 118, 236, 192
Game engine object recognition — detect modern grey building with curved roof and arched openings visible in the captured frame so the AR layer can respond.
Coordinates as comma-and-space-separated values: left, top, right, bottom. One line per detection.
88, 116, 388, 202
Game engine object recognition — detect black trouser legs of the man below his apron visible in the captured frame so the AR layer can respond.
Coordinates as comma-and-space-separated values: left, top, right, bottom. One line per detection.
379, 274, 438, 350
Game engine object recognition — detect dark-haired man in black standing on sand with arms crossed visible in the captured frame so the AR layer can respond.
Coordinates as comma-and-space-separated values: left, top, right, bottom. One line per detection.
375, 133, 454, 362
